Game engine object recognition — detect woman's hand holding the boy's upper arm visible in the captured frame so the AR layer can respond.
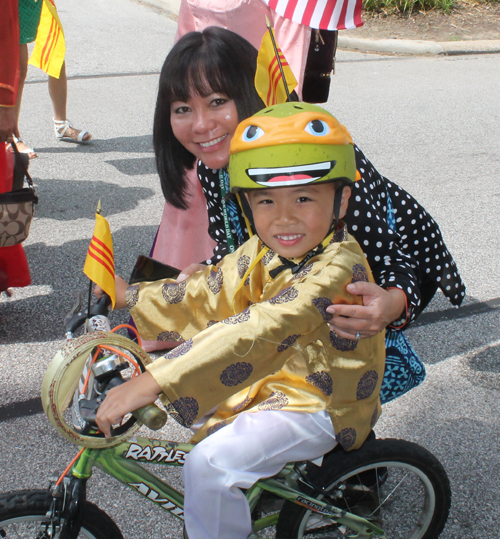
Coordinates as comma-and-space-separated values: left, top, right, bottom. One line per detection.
326, 281, 406, 340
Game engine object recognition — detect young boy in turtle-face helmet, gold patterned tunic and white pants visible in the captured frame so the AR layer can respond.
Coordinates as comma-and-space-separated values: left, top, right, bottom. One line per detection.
97, 103, 385, 539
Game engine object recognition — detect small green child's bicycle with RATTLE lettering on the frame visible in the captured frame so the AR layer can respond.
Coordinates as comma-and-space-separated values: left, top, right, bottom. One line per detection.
0, 294, 451, 539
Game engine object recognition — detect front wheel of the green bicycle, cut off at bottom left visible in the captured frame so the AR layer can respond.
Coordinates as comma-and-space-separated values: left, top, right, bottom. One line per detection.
0, 490, 123, 539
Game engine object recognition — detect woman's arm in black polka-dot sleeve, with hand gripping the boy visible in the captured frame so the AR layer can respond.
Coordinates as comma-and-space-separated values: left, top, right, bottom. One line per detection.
327, 147, 421, 339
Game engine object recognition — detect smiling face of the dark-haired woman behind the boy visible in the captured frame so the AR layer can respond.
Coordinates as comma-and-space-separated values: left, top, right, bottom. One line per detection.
170, 93, 239, 169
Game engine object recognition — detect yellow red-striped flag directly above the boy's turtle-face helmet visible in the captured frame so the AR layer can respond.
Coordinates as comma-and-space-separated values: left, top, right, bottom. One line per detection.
255, 28, 297, 107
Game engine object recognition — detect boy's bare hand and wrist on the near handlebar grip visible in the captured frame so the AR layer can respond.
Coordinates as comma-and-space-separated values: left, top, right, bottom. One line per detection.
96, 371, 161, 438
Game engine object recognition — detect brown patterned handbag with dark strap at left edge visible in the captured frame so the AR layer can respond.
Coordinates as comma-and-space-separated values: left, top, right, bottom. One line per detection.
0, 147, 38, 247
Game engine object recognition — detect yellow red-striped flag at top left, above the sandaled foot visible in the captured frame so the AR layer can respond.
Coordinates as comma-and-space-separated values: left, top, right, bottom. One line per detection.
29, 0, 66, 79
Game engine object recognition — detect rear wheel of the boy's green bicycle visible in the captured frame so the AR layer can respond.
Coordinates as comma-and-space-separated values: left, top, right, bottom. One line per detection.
276, 439, 451, 539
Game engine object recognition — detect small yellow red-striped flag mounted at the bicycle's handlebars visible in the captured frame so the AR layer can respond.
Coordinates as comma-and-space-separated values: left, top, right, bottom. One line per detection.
83, 213, 116, 308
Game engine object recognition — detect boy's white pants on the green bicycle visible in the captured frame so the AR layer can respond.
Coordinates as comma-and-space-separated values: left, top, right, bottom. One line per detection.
182, 410, 336, 539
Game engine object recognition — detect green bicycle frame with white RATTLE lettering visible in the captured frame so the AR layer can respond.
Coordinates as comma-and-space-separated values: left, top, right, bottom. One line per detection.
71, 437, 385, 538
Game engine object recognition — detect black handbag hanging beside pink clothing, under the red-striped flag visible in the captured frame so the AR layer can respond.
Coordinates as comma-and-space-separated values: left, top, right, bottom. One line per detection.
302, 29, 338, 103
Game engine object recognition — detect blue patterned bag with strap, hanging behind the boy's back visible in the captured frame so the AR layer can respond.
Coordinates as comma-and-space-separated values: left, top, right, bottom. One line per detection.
380, 191, 425, 404
